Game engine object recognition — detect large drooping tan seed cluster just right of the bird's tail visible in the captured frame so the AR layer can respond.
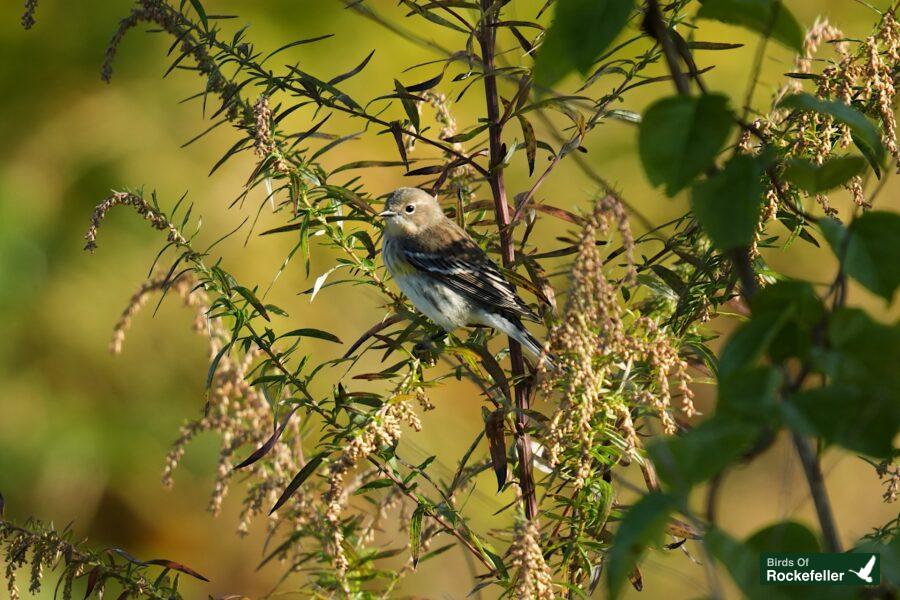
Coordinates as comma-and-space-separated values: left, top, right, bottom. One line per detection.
542, 197, 694, 489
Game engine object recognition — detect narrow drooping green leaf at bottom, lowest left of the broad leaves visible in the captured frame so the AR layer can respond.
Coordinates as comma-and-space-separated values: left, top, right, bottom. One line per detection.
607, 492, 675, 598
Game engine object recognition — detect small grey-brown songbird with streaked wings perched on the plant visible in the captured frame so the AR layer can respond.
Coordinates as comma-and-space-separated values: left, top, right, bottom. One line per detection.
378, 187, 553, 367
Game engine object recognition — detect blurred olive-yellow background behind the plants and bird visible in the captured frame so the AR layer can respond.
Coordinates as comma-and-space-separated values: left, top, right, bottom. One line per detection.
0, 0, 898, 599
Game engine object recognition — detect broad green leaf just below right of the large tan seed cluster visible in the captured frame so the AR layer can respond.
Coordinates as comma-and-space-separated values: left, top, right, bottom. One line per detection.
647, 416, 758, 493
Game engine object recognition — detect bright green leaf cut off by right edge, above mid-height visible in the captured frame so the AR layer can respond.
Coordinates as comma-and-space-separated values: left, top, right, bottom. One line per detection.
819, 210, 900, 302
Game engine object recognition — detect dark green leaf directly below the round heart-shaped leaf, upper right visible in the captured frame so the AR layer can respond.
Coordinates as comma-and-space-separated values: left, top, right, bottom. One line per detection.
691, 154, 766, 250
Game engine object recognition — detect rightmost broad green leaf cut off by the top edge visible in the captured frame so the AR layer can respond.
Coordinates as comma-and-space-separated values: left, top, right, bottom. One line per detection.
697, 0, 803, 52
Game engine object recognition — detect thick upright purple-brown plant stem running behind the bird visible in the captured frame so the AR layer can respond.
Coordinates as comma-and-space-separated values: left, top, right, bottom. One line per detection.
478, 0, 537, 520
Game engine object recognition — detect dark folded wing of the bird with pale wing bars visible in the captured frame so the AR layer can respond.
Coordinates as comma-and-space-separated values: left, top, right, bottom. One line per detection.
403, 238, 540, 321
